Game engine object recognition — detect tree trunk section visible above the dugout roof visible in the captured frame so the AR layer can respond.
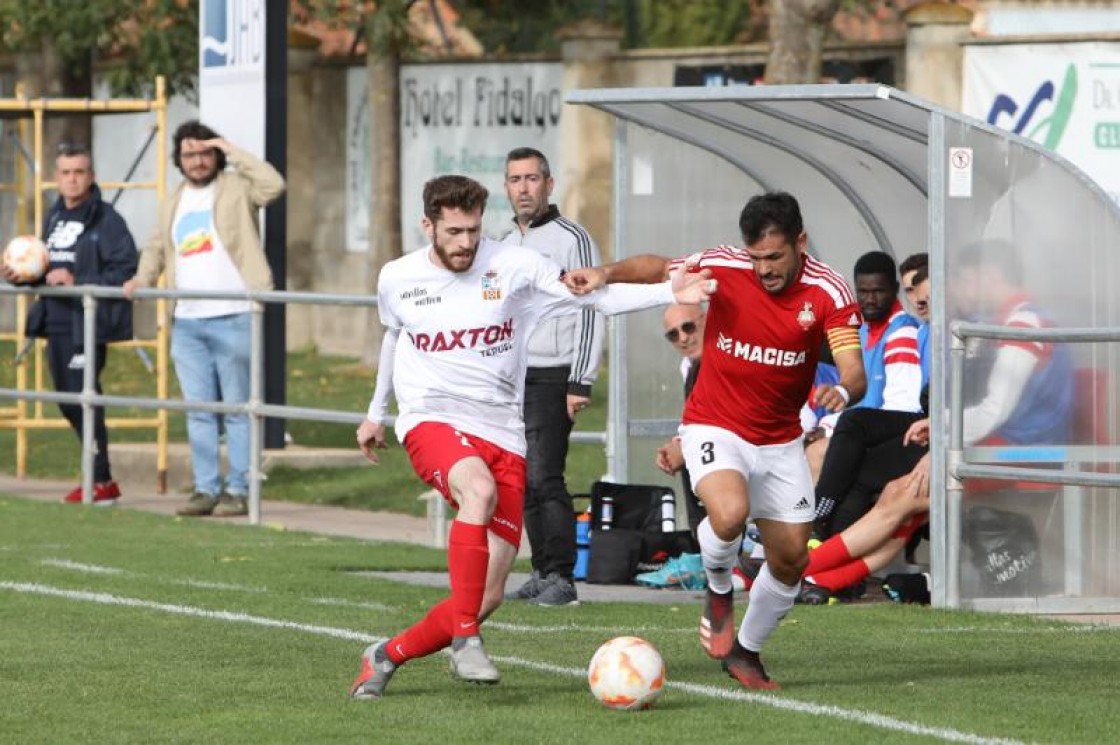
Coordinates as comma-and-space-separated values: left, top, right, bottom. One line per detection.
765, 0, 840, 85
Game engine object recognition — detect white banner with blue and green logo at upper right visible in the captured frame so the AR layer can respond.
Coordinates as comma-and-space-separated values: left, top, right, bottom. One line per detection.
962, 41, 1120, 202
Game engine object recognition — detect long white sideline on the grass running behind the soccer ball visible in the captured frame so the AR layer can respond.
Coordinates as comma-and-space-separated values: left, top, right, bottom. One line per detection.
0, 581, 1021, 745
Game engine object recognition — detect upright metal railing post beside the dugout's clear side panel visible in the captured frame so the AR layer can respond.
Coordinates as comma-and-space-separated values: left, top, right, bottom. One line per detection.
945, 324, 965, 608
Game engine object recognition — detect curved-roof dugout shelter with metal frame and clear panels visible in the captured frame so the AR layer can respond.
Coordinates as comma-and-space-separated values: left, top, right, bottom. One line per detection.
567, 84, 1120, 613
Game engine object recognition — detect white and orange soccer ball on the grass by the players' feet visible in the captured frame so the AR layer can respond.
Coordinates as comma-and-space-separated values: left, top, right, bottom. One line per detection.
587, 636, 665, 710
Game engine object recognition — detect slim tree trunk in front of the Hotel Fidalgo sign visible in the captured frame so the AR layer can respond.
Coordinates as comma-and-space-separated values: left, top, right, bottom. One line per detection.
364, 25, 403, 364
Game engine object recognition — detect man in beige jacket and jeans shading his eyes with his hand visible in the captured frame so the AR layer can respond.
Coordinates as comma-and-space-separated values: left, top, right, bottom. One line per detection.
124, 121, 284, 516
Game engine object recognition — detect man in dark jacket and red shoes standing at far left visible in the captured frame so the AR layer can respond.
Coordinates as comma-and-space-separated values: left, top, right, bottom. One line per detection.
3, 143, 138, 504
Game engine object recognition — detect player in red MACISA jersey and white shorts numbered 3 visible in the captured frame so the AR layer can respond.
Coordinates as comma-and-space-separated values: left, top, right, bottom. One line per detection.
567, 193, 867, 689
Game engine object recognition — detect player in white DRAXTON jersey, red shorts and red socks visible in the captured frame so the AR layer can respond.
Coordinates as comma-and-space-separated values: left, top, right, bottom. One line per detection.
351, 176, 715, 699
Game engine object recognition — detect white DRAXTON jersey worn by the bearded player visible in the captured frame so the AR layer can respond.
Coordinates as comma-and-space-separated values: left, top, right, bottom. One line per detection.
371, 239, 673, 455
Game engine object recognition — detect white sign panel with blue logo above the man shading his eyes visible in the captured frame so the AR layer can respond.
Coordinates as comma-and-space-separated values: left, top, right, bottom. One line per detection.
198, 0, 265, 158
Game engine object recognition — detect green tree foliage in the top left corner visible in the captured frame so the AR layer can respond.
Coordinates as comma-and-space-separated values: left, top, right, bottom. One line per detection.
0, 0, 198, 96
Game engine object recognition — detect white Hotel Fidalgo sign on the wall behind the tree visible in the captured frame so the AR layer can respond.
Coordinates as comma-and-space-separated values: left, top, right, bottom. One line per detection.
346, 63, 564, 251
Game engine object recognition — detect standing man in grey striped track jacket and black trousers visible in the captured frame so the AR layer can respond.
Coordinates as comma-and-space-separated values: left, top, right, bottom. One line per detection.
504, 148, 604, 606
